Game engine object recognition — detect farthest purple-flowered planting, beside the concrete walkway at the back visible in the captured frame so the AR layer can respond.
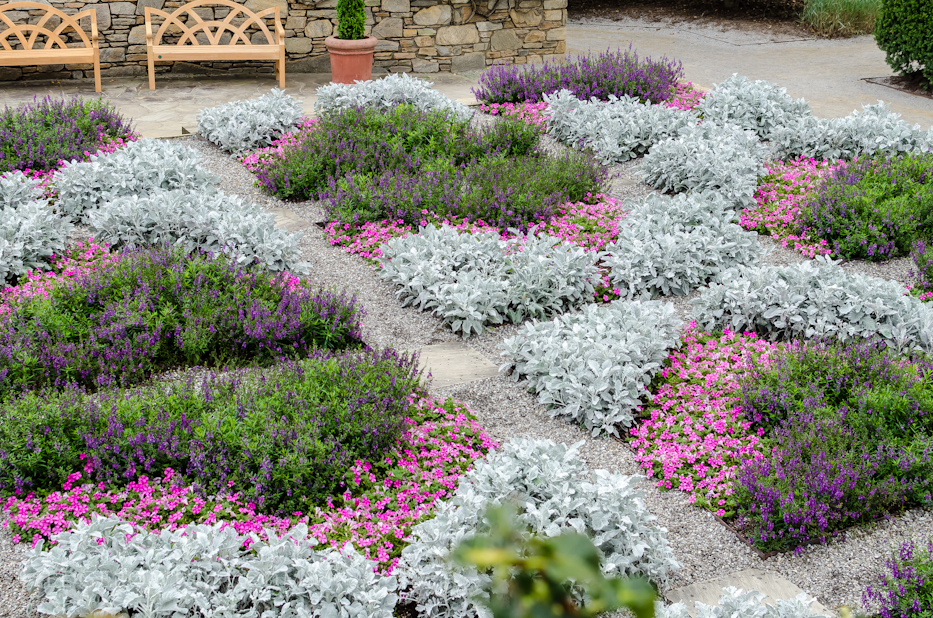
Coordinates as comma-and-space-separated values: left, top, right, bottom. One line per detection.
473, 46, 683, 103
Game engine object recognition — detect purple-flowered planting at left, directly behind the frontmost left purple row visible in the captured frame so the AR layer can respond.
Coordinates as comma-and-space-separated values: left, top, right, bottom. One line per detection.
0, 243, 362, 393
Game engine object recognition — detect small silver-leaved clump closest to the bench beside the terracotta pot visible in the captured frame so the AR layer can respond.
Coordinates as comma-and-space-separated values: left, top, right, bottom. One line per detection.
198, 88, 302, 152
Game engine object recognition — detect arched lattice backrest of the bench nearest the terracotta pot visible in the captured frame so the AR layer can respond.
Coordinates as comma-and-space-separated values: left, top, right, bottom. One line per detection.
146, 0, 281, 45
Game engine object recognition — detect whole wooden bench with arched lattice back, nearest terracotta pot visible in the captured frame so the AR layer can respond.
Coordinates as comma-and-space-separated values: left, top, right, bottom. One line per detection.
146, 0, 285, 90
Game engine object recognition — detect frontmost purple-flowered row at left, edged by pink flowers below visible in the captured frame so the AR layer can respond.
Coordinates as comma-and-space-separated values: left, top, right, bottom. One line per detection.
0, 350, 420, 515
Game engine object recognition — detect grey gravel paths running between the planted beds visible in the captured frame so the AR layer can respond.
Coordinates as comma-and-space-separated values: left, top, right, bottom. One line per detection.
1, 71, 933, 606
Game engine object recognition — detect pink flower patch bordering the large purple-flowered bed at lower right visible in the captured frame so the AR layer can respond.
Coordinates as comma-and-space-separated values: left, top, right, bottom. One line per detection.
630, 323, 775, 517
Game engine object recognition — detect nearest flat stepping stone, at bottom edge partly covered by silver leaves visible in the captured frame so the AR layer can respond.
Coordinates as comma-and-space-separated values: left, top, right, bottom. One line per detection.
664, 569, 835, 616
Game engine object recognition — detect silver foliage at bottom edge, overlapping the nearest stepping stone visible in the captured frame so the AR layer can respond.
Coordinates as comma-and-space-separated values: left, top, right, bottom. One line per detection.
654, 586, 827, 618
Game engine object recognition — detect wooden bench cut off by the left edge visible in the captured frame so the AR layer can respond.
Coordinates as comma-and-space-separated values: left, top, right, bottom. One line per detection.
0, 2, 100, 92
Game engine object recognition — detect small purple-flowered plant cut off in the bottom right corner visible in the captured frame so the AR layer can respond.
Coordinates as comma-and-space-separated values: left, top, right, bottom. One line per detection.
862, 541, 933, 618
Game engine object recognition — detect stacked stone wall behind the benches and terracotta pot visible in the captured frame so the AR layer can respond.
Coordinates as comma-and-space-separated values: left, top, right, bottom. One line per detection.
0, 0, 567, 81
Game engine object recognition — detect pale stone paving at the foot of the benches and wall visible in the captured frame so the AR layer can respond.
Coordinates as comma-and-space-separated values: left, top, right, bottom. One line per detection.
0, 73, 476, 137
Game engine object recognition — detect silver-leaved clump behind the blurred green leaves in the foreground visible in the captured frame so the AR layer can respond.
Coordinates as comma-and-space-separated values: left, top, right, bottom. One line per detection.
397, 439, 680, 618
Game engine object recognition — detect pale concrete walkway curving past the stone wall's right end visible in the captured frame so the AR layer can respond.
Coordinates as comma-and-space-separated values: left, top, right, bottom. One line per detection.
567, 19, 933, 129
